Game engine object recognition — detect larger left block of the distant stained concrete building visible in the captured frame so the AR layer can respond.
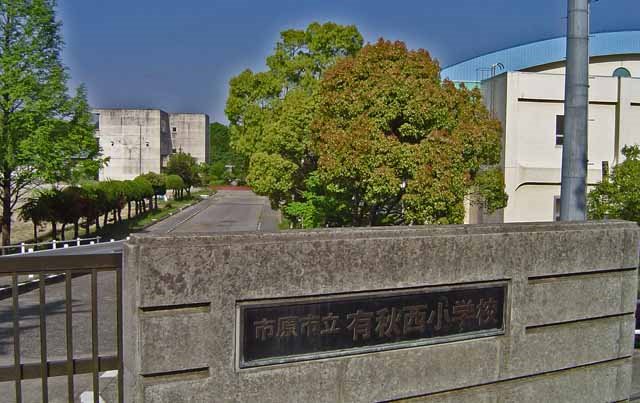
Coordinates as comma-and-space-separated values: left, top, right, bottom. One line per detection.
93, 109, 169, 180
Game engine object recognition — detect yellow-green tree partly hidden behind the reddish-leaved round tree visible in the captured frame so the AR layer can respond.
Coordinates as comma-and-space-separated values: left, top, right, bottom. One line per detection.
225, 22, 363, 211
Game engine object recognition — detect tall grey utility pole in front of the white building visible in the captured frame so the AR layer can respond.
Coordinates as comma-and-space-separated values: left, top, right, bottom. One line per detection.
560, 0, 589, 221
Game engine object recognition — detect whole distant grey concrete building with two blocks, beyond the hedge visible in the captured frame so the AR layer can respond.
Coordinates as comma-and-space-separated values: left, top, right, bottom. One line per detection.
93, 109, 209, 180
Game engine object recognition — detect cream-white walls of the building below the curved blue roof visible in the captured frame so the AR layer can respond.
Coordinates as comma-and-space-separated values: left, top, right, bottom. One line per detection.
482, 72, 640, 223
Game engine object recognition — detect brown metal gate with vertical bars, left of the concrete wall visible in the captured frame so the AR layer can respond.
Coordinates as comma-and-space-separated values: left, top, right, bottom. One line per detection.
0, 254, 124, 403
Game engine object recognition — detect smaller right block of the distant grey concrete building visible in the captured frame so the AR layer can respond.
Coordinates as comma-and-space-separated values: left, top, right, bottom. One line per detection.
169, 113, 210, 163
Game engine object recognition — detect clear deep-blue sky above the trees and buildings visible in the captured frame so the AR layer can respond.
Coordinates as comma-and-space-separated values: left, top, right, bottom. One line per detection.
58, 0, 640, 122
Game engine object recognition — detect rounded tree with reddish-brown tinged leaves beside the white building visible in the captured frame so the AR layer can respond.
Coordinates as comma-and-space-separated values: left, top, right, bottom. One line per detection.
313, 39, 506, 226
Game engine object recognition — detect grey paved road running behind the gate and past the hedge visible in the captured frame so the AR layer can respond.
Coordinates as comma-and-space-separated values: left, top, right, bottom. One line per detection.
0, 191, 279, 402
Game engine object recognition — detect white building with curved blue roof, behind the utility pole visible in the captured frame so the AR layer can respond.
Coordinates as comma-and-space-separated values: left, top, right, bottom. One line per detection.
442, 31, 640, 223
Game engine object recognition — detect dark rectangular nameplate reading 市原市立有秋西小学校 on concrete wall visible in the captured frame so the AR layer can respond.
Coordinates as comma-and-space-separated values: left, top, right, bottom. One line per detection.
238, 283, 507, 368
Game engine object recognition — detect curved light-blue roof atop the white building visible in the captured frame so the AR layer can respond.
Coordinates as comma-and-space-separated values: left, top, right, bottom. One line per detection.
440, 31, 640, 82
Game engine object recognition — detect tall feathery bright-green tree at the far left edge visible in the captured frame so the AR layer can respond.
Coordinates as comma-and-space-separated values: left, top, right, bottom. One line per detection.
0, 0, 98, 245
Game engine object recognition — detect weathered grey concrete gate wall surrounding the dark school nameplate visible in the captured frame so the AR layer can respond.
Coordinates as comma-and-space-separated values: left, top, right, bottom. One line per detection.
125, 222, 639, 402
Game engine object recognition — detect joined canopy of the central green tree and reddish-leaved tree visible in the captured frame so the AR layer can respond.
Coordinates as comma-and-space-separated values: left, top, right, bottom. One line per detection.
232, 31, 507, 227
